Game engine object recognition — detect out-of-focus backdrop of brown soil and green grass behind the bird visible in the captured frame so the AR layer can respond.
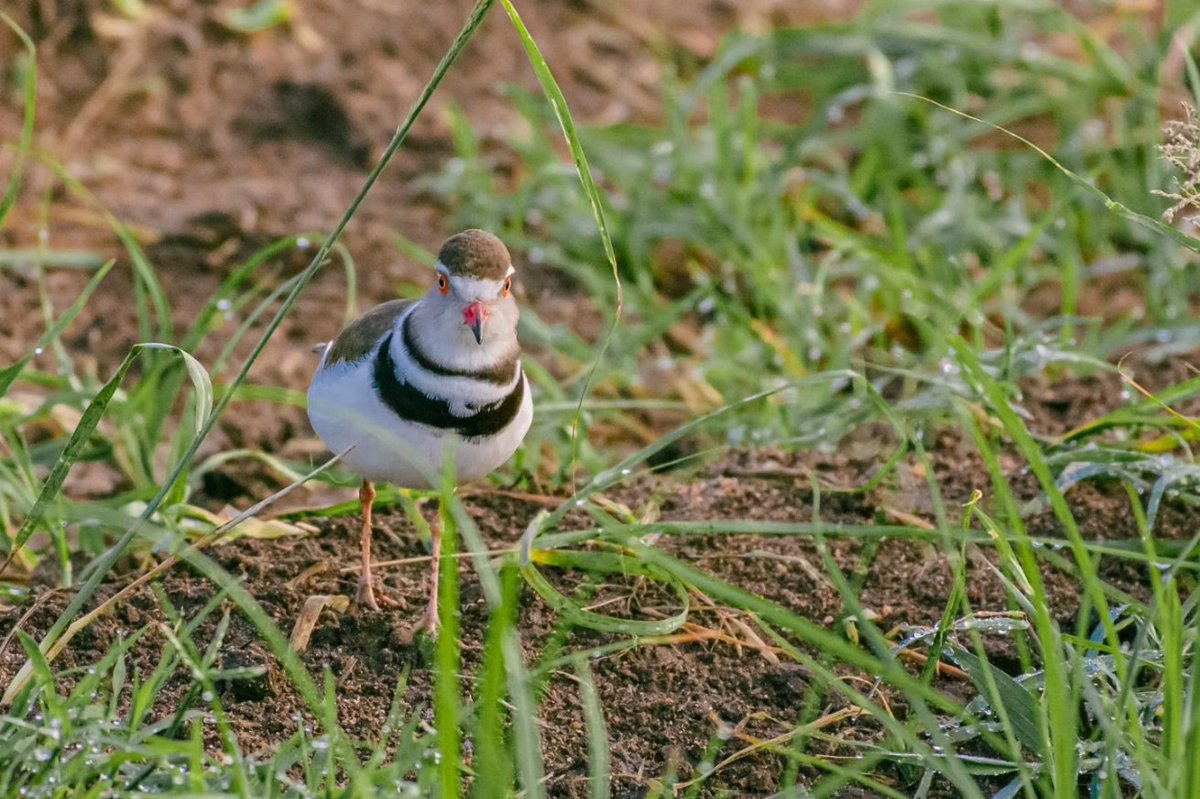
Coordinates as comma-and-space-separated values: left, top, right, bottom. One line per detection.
0, 0, 1198, 499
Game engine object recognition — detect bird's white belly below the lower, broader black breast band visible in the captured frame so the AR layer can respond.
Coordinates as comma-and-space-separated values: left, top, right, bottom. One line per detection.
308, 358, 533, 488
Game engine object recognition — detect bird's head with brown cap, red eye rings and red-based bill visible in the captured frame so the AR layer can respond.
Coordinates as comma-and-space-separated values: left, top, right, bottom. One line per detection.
428, 229, 517, 346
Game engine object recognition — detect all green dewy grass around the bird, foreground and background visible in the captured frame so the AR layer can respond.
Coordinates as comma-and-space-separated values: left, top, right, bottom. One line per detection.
0, 0, 1200, 798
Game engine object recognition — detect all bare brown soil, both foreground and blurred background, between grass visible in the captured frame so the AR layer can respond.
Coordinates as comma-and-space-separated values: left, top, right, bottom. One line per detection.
0, 0, 1198, 797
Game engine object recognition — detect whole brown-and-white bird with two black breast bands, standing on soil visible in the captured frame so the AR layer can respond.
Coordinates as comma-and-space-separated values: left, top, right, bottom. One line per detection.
308, 228, 533, 635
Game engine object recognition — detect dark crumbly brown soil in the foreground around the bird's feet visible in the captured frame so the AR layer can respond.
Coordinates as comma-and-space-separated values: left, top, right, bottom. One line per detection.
0, 388, 1200, 797
